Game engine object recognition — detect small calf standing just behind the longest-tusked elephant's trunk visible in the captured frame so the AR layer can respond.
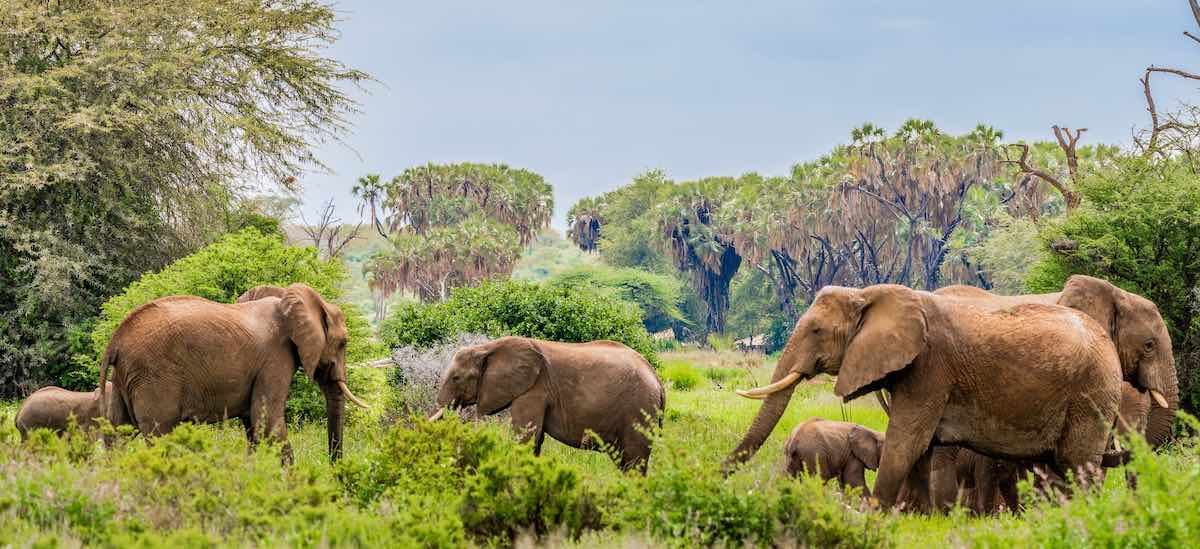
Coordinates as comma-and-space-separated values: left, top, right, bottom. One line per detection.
784, 420, 883, 497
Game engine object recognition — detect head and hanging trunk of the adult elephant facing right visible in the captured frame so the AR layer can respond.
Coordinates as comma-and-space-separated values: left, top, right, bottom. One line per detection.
246, 284, 367, 460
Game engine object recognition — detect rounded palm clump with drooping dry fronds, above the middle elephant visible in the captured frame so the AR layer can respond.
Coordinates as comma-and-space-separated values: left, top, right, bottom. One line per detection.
366, 163, 554, 302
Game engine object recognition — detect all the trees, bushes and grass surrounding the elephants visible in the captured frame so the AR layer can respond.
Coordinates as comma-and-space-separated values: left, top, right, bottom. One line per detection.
0, 0, 1200, 548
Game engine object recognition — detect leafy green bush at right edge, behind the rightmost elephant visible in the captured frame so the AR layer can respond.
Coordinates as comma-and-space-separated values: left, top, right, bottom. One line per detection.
1026, 158, 1200, 410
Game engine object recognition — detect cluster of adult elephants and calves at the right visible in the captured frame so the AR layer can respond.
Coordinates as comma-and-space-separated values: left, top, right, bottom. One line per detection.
725, 276, 1180, 511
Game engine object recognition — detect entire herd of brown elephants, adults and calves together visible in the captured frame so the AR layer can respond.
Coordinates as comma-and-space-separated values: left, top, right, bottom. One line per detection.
17, 276, 1180, 511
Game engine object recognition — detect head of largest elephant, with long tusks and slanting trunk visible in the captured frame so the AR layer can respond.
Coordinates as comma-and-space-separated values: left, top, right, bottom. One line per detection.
725, 284, 925, 471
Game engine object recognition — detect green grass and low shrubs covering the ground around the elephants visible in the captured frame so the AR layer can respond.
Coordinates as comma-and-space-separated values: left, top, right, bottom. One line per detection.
0, 352, 1200, 547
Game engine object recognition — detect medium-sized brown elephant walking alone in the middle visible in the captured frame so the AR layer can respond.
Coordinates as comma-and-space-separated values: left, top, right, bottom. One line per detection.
430, 337, 666, 475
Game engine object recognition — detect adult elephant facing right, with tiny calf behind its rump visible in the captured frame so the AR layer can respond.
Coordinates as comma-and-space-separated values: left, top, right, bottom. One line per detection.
101, 284, 366, 463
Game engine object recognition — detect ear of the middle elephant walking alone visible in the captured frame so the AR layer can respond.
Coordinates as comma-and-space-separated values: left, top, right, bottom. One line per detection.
478, 337, 547, 415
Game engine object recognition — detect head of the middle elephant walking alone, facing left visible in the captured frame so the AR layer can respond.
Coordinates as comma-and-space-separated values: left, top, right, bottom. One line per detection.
430, 337, 546, 420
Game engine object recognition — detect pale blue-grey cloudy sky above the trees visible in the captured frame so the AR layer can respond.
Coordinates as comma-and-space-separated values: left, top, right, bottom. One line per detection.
295, 0, 1200, 229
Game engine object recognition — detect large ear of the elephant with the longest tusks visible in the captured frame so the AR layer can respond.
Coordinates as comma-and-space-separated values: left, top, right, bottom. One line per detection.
834, 284, 925, 400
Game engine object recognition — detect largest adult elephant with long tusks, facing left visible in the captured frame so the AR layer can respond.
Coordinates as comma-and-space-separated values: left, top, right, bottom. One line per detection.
725, 284, 1121, 507
